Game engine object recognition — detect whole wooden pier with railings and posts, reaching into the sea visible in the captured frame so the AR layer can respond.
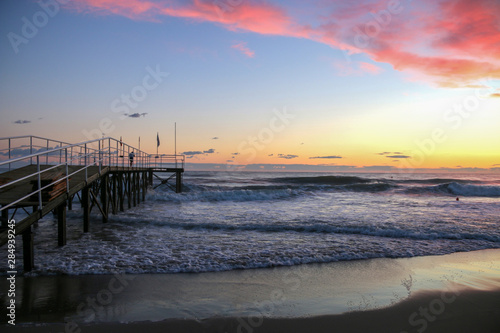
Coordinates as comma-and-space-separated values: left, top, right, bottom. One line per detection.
0, 138, 184, 272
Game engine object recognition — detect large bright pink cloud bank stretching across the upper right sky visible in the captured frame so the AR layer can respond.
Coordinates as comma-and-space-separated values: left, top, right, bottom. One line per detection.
67, 0, 500, 88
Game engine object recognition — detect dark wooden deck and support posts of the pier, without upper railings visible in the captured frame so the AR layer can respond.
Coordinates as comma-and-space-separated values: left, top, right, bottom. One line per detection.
0, 165, 184, 271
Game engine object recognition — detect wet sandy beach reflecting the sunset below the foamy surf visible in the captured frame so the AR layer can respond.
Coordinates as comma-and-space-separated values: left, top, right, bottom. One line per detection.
1, 250, 500, 332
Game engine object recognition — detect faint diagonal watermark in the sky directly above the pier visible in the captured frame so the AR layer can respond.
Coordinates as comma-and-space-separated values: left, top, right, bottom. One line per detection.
82, 65, 170, 140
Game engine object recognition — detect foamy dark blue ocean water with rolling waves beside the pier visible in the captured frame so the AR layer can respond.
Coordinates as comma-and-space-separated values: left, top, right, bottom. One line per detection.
0, 171, 500, 275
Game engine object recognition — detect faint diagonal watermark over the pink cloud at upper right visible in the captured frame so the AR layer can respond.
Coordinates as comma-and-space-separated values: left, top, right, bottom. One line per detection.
341, 0, 412, 63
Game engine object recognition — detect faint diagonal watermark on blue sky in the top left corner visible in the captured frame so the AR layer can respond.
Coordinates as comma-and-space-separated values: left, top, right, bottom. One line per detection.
7, 0, 71, 54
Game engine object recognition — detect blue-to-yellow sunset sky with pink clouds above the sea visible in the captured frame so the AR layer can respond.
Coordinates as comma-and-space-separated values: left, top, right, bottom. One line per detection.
0, 0, 500, 171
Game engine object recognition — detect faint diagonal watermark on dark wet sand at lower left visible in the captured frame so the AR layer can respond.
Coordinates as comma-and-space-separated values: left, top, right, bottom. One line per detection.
61, 273, 135, 333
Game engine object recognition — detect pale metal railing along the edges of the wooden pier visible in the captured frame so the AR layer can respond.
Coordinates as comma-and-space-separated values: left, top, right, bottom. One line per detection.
0, 136, 185, 211
